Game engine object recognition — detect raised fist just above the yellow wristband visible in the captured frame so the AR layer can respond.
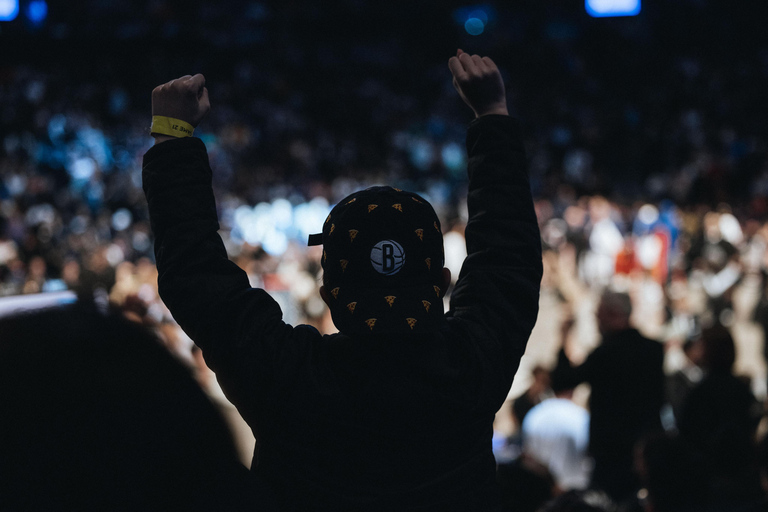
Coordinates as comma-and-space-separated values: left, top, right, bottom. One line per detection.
152, 74, 211, 127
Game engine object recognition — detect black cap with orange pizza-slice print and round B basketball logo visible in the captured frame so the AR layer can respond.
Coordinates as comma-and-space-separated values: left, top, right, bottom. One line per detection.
309, 187, 446, 334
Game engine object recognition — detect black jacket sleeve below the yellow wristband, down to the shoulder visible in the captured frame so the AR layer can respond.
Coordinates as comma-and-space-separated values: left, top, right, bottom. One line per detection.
143, 137, 291, 388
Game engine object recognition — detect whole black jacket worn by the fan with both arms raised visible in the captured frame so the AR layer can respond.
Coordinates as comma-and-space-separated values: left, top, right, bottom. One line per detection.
144, 116, 542, 511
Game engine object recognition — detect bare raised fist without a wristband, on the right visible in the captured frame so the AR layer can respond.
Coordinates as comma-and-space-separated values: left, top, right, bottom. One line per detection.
448, 50, 509, 117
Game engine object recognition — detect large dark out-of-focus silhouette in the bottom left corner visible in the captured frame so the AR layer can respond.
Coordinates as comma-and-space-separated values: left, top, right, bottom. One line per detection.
0, 306, 268, 511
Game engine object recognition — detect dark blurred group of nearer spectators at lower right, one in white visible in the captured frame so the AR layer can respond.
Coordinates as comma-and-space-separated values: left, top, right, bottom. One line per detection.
495, 316, 768, 512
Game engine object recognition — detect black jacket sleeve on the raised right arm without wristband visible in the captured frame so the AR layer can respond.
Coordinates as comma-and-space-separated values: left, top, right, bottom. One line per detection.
448, 115, 542, 384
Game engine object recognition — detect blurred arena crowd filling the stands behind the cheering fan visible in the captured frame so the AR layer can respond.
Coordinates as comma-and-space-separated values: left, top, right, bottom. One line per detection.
0, 0, 768, 508
